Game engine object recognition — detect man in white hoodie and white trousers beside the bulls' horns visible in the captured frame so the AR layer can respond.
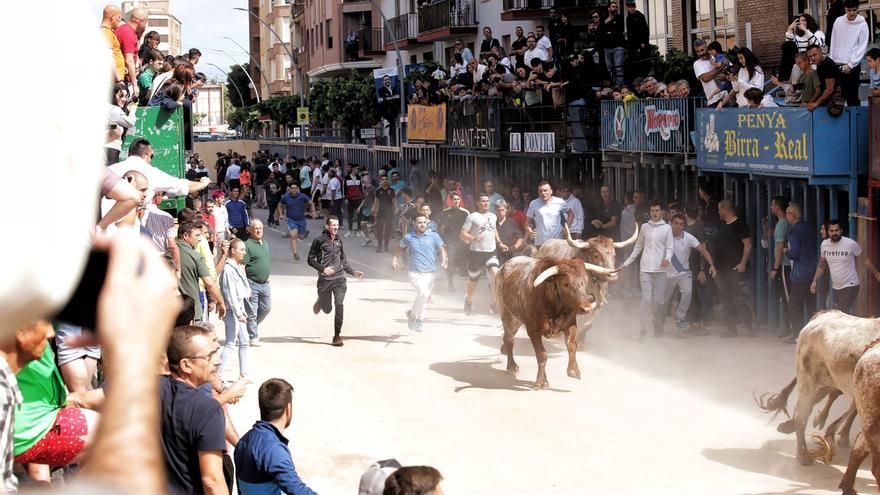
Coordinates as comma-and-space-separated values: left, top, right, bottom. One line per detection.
623, 201, 673, 342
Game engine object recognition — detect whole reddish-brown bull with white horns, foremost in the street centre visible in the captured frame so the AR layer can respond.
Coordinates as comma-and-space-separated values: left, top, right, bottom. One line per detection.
495, 256, 615, 389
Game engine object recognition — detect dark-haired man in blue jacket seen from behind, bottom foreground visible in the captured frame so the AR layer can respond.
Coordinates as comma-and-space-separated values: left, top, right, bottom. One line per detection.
235, 378, 317, 495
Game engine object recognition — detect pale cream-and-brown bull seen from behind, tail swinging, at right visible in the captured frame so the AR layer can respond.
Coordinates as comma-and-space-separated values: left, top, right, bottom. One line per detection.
758, 311, 880, 466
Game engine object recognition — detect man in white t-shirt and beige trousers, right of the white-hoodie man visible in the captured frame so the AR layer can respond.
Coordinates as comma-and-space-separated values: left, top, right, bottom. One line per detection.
663, 215, 715, 337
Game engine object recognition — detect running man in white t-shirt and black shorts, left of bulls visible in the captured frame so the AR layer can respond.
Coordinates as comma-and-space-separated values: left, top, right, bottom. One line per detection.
459, 193, 501, 315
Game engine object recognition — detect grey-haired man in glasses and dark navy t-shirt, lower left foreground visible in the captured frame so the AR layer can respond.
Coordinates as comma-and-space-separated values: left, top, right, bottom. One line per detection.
159, 325, 229, 495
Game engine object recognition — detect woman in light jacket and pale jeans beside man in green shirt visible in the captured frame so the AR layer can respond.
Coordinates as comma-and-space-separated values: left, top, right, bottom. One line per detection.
220, 238, 251, 379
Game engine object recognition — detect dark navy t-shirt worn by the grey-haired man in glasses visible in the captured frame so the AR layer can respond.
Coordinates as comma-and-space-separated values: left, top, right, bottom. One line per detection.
159, 376, 226, 494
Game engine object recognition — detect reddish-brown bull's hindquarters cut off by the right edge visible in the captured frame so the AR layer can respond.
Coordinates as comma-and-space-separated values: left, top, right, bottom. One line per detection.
840, 340, 880, 495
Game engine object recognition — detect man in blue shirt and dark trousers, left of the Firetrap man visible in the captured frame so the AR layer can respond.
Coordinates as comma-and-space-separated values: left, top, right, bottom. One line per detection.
785, 202, 819, 344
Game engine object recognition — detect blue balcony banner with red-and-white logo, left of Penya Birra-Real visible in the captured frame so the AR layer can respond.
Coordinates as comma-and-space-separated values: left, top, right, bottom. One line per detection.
600, 98, 705, 154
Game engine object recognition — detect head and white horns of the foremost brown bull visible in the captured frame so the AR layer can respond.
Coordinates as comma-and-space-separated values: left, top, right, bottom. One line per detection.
532, 259, 620, 314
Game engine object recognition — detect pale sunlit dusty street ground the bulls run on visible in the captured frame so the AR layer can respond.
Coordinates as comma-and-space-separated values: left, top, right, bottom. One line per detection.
222, 210, 877, 494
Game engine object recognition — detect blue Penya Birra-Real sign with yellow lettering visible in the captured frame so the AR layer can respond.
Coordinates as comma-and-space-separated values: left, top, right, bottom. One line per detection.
695, 108, 813, 176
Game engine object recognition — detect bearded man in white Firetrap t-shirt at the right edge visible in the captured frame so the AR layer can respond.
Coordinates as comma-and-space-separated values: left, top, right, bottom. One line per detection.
810, 220, 880, 314
